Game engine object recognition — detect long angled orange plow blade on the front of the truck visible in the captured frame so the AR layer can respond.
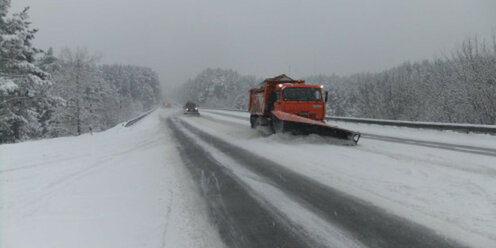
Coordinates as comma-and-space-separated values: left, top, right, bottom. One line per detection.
271, 110, 360, 145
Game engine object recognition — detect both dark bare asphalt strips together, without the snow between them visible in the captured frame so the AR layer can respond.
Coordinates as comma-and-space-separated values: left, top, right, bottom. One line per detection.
168, 116, 468, 247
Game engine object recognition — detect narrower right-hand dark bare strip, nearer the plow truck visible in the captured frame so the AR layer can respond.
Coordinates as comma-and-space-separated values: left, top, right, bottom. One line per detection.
175, 116, 463, 247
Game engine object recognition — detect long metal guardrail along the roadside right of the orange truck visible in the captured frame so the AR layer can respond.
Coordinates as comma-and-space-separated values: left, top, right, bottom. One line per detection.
326, 116, 496, 135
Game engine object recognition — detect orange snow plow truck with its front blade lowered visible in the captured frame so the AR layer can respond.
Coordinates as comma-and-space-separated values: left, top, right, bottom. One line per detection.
248, 74, 360, 145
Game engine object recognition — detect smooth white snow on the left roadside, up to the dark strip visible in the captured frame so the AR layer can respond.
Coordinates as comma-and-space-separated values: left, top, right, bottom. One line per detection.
0, 110, 223, 248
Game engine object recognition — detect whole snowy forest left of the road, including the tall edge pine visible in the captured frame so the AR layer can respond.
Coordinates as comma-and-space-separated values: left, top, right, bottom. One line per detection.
0, 0, 160, 143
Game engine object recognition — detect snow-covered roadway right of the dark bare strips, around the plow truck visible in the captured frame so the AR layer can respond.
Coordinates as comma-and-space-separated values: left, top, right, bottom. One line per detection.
194, 111, 496, 247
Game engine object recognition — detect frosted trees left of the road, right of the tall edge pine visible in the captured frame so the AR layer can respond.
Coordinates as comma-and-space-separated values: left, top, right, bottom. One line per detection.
44, 57, 160, 137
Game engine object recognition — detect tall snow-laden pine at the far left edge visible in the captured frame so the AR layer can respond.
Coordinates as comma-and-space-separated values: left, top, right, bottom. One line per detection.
0, 0, 55, 143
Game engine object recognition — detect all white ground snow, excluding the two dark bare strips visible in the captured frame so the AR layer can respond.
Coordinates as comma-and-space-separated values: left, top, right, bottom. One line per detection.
0, 109, 496, 248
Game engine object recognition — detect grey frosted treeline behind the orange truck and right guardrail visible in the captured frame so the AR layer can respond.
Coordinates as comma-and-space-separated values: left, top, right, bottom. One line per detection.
179, 35, 496, 125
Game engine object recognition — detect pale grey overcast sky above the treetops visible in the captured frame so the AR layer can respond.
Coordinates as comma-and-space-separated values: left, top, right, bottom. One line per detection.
11, 0, 496, 85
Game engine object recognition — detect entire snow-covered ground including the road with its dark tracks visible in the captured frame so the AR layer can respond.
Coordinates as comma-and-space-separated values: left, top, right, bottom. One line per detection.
0, 109, 496, 247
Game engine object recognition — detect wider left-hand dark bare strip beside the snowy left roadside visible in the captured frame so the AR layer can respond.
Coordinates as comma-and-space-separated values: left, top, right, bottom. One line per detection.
167, 119, 318, 248
